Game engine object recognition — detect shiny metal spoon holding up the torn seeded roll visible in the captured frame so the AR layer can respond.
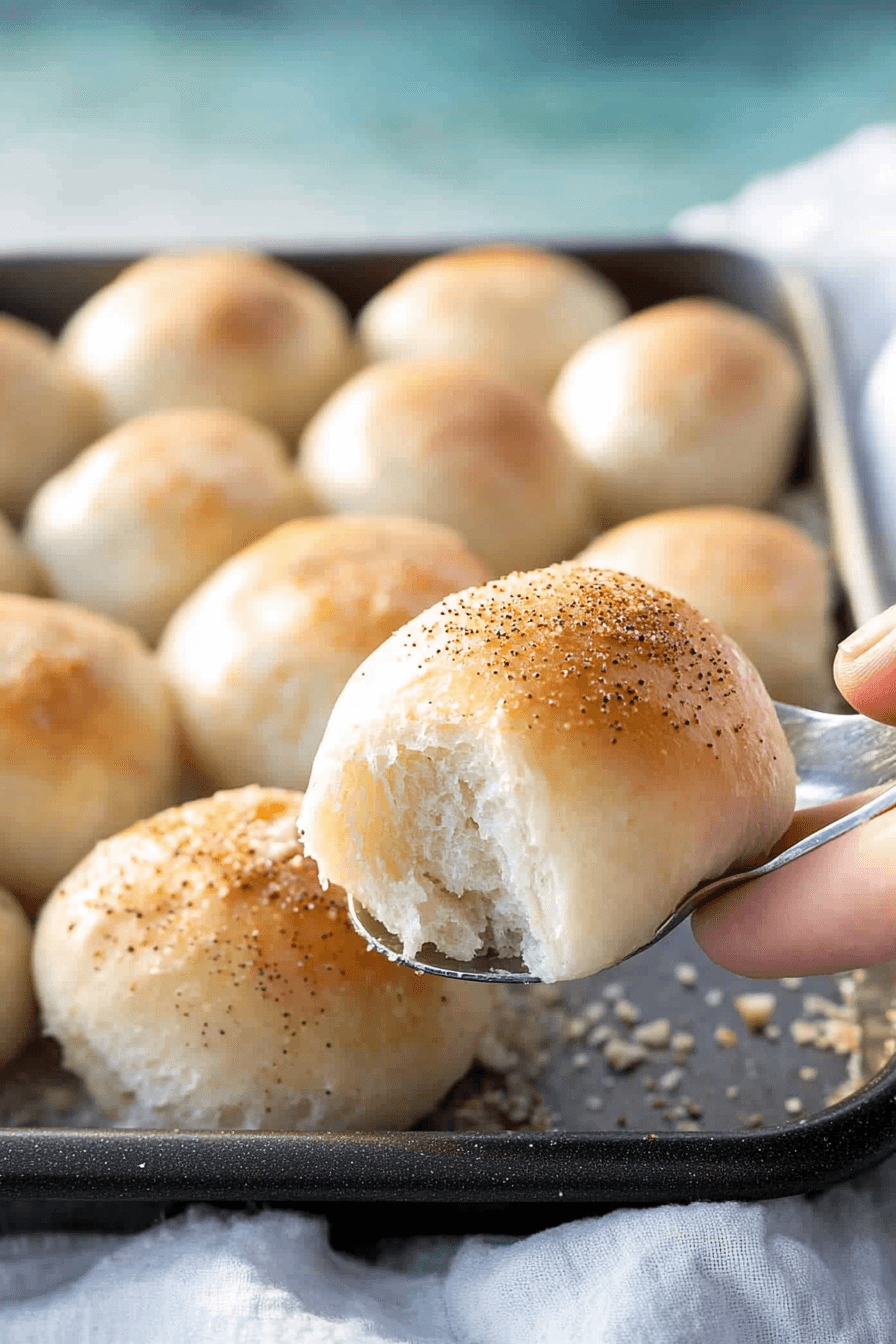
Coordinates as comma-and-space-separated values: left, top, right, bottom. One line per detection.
348, 703, 896, 984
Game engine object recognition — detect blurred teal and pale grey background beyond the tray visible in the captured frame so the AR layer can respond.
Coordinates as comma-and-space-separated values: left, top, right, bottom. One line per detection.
0, 0, 896, 250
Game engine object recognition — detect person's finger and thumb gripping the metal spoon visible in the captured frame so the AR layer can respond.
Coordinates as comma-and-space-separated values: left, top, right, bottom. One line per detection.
692, 606, 896, 978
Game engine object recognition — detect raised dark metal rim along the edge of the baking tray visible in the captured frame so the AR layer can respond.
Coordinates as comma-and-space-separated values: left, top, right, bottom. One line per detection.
0, 235, 896, 1204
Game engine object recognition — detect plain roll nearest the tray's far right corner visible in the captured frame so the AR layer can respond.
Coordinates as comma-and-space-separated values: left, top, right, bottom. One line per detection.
551, 298, 806, 523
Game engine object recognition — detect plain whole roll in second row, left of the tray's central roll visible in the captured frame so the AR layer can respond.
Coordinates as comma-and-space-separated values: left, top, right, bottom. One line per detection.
24, 409, 322, 642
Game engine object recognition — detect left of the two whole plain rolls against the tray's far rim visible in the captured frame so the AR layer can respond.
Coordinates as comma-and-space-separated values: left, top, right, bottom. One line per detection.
60, 251, 357, 441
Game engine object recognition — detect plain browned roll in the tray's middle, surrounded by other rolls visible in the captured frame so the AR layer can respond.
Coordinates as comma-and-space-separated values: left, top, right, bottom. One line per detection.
300, 359, 596, 574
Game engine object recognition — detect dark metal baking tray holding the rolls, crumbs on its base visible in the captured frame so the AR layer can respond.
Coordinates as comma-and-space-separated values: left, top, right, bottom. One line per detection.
0, 241, 896, 1243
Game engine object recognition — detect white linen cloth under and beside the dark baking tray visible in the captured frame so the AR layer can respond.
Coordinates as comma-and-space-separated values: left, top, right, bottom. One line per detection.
0, 126, 896, 1344
